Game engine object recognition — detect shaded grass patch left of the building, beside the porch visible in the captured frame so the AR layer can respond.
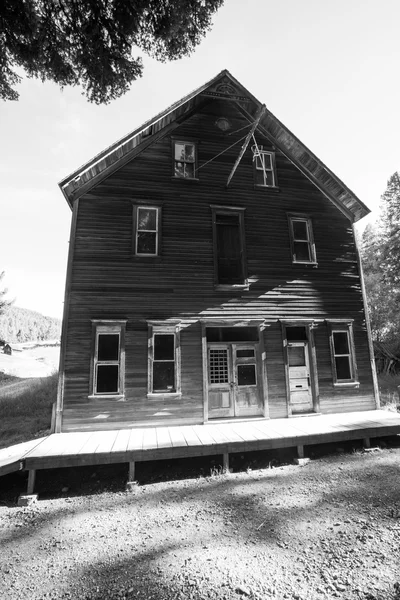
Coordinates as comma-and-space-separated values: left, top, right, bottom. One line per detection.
0, 373, 58, 448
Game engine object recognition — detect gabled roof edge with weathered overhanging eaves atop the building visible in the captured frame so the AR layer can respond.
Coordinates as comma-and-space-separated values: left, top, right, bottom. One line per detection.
59, 70, 370, 222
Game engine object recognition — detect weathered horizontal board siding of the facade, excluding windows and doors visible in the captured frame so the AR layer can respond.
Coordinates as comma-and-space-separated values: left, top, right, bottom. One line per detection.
62, 100, 375, 431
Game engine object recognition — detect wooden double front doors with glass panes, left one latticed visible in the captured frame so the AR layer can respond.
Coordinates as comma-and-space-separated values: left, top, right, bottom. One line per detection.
207, 343, 263, 419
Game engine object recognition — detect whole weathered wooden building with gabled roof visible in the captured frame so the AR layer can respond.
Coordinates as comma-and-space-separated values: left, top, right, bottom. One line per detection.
54, 71, 379, 432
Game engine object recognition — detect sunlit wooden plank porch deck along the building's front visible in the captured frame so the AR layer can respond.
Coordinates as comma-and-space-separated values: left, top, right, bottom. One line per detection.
0, 410, 400, 488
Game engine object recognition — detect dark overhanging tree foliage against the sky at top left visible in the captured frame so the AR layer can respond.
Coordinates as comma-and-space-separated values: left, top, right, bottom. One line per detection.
0, 0, 223, 104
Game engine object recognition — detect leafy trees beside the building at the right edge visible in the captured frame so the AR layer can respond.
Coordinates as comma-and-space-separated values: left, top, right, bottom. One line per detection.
362, 172, 400, 344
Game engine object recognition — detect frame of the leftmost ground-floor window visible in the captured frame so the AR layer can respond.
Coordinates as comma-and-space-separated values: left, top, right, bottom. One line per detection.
89, 319, 126, 400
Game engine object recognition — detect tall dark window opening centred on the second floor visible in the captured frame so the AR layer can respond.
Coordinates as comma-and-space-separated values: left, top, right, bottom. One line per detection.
211, 206, 246, 285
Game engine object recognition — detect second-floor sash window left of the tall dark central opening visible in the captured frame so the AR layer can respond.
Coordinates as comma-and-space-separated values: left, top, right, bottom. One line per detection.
134, 206, 161, 256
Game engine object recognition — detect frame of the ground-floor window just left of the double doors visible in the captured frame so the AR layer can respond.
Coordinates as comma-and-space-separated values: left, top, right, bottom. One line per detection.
147, 323, 182, 398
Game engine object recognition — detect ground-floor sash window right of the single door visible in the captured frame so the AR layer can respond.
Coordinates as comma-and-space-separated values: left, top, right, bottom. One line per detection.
329, 321, 357, 384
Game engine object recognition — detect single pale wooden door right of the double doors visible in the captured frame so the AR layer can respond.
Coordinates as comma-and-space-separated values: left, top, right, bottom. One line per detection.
288, 342, 313, 414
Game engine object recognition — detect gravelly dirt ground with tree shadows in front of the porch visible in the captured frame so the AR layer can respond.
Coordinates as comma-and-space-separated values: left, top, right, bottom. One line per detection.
0, 436, 400, 600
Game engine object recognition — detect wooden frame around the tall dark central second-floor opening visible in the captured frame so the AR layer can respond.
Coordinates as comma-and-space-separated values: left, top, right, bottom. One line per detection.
210, 204, 249, 290
